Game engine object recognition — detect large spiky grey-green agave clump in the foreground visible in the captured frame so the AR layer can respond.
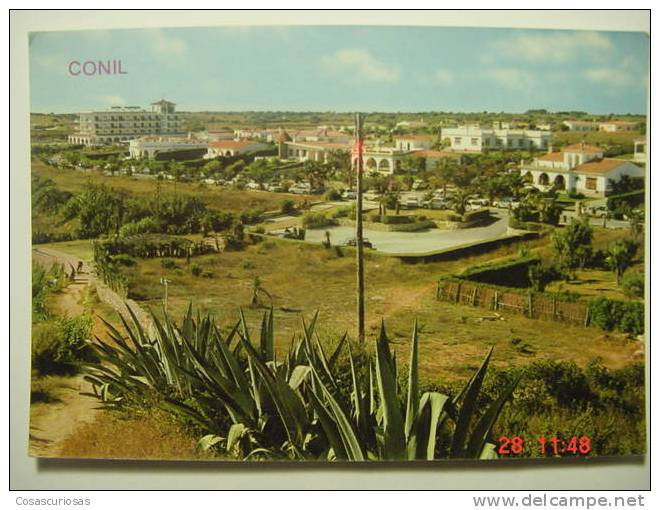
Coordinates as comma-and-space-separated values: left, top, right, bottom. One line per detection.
86, 307, 517, 461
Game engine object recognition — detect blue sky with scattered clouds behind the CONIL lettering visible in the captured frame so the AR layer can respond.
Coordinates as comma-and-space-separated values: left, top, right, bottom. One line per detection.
30, 26, 649, 113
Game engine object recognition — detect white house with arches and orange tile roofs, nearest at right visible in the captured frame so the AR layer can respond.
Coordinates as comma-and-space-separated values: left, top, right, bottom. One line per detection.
520, 143, 644, 196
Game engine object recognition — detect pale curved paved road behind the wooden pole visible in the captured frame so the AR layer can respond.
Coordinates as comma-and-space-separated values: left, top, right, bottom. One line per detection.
306, 209, 509, 254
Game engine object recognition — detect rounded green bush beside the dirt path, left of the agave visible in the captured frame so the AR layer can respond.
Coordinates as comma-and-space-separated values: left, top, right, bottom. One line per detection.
32, 315, 95, 375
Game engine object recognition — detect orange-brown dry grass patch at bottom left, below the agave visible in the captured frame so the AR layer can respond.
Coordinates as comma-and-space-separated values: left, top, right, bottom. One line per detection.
60, 409, 210, 460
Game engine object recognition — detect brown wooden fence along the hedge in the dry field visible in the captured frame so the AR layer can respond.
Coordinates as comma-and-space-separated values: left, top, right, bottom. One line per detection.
436, 280, 589, 326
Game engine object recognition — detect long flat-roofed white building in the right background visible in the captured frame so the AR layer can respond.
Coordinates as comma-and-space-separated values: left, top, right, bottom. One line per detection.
442, 126, 552, 152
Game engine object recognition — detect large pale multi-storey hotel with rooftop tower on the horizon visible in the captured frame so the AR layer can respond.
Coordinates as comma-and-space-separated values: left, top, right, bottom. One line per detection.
69, 99, 183, 145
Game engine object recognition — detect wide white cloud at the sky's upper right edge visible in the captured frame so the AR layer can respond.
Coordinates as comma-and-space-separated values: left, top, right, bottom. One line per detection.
495, 32, 612, 64
